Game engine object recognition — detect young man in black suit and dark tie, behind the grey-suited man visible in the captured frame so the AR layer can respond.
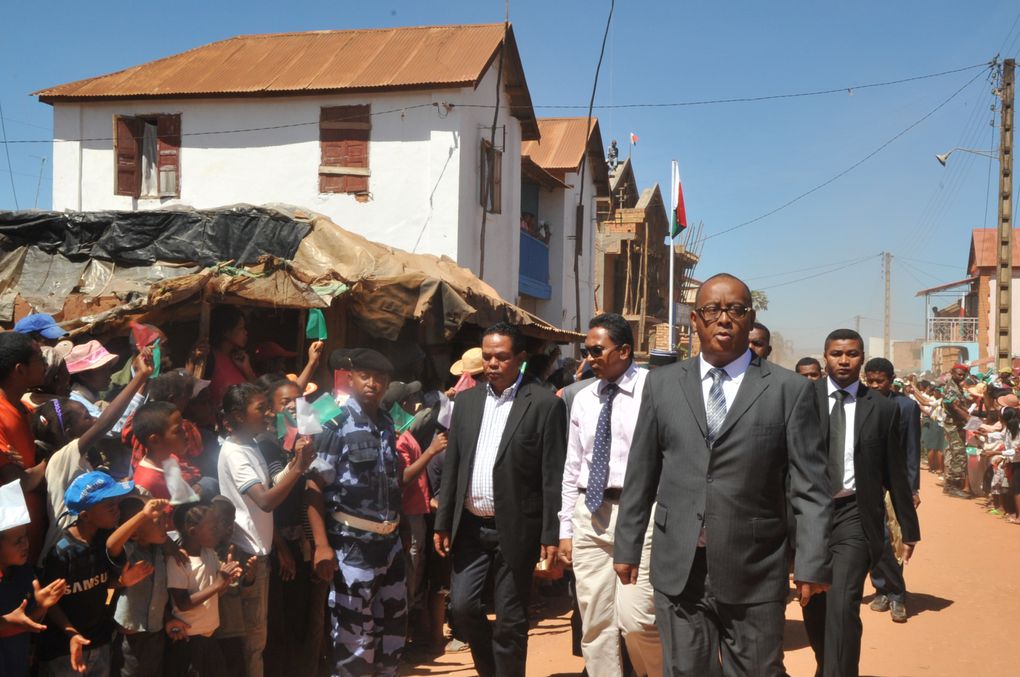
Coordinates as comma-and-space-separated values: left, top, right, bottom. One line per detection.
804, 329, 921, 677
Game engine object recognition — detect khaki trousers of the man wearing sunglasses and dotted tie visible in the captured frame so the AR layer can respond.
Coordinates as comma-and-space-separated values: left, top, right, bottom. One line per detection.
572, 494, 662, 677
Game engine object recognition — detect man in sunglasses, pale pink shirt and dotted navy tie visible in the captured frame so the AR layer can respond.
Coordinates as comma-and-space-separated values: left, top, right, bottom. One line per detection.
560, 313, 662, 677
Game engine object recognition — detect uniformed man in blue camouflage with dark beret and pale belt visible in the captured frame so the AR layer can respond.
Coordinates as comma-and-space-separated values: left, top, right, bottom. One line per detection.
318, 349, 407, 676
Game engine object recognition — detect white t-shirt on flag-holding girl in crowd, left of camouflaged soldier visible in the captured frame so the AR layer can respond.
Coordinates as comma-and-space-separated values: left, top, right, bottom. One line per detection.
216, 435, 272, 557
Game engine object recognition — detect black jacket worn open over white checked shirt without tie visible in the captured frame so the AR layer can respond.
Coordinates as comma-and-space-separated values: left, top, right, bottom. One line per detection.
436, 376, 567, 573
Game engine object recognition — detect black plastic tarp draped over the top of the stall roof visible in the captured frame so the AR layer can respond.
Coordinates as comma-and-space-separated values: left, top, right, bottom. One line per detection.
0, 205, 310, 266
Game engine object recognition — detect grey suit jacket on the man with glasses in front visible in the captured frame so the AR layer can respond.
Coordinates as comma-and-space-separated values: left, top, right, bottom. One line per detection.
614, 357, 832, 604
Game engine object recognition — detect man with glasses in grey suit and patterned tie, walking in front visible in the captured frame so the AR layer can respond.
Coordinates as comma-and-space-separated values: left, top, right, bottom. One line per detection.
614, 274, 831, 677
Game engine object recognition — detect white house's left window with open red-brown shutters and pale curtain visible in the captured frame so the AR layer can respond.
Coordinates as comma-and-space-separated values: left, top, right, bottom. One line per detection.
113, 114, 181, 198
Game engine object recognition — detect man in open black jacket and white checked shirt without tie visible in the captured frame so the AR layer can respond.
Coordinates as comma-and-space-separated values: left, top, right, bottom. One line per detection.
435, 323, 566, 677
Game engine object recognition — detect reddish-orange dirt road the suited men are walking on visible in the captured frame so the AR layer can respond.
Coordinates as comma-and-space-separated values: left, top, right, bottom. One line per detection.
404, 471, 1020, 677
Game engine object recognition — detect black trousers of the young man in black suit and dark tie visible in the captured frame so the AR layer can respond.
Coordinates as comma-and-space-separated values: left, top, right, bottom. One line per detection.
804, 497, 871, 677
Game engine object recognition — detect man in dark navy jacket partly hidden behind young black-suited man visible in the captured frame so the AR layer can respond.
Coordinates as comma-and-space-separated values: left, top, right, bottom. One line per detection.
864, 357, 921, 623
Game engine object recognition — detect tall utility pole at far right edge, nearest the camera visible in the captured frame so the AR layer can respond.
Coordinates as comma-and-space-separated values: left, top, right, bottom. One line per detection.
996, 59, 1016, 371
